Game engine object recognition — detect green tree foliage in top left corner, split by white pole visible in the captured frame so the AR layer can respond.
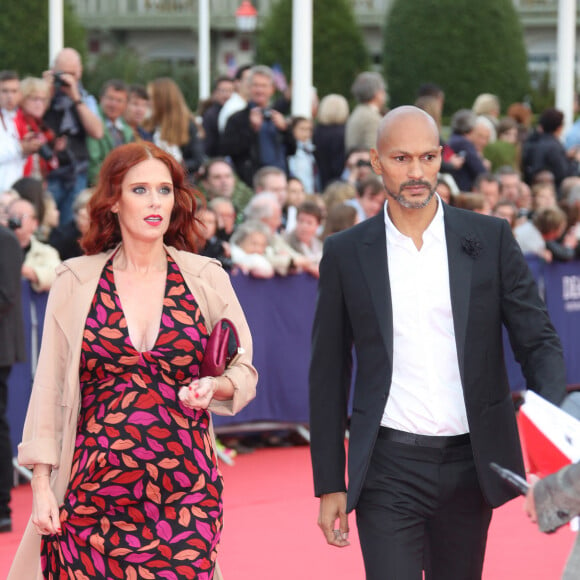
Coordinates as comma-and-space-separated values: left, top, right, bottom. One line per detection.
0, 0, 87, 77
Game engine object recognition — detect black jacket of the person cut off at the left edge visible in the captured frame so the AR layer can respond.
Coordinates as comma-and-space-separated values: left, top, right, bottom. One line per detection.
0, 226, 26, 367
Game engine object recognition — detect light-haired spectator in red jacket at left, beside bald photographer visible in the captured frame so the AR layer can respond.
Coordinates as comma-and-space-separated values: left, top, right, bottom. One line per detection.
14, 77, 66, 180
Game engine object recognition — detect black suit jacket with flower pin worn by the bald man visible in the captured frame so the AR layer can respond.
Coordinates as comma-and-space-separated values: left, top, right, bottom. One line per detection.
310, 206, 566, 511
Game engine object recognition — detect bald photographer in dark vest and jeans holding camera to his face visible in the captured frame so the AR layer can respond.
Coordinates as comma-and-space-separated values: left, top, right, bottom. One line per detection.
44, 48, 104, 224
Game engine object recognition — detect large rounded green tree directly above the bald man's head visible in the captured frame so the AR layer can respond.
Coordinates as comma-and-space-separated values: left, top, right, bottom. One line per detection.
384, 0, 529, 113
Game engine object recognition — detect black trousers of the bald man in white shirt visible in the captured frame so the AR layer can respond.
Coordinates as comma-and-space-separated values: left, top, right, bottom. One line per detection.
356, 427, 491, 580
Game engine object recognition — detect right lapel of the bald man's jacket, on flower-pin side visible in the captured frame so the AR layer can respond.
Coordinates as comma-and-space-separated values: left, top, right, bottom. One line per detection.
444, 205, 473, 382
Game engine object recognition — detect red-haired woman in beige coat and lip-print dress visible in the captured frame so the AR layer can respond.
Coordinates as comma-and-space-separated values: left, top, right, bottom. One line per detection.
9, 142, 257, 580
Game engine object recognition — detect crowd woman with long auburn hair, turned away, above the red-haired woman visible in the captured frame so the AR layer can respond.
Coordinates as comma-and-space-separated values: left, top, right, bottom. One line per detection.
145, 77, 204, 179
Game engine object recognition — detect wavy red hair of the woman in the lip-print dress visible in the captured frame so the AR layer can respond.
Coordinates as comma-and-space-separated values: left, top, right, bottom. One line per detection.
81, 141, 201, 255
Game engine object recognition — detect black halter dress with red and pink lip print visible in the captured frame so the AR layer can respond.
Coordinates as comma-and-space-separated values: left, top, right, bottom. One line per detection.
41, 256, 222, 580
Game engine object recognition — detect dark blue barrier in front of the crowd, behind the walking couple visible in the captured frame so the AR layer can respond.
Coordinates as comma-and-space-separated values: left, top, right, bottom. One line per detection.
8, 259, 580, 450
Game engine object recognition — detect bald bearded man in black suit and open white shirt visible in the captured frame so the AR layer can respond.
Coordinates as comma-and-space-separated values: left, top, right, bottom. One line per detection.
310, 107, 565, 580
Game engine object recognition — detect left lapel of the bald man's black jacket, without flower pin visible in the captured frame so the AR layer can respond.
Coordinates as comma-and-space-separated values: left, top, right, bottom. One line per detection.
357, 212, 393, 361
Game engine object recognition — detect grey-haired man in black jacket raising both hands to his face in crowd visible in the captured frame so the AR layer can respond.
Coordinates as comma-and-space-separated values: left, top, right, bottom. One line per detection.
221, 65, 296, 187
